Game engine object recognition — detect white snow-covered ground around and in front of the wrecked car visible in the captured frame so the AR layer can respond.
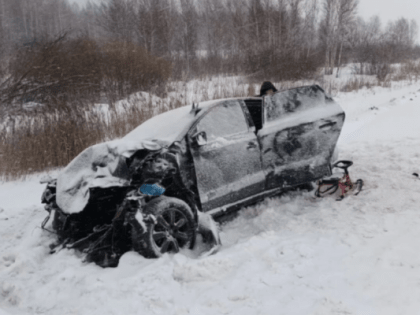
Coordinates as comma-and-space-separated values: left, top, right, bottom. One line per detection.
0, 85, 420, 315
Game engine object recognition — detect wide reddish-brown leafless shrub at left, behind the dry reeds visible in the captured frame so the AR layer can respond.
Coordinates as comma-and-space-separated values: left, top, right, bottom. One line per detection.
0, 35, 172, 106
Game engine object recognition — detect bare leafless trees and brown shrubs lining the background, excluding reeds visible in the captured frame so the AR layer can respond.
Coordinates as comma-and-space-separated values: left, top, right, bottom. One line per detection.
0, 0, 420, 107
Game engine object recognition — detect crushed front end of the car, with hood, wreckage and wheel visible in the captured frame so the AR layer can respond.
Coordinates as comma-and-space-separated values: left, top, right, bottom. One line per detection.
42, 103, 219, 267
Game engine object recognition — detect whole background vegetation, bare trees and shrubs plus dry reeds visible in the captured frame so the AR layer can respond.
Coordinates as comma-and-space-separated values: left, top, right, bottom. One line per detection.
0, 0, 420, 178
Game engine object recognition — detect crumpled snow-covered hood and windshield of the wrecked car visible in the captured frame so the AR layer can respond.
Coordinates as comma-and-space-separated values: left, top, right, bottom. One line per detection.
57, 106, 199, 214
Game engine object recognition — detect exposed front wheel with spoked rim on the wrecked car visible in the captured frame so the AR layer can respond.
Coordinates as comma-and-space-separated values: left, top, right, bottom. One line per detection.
132, 196, 196, 258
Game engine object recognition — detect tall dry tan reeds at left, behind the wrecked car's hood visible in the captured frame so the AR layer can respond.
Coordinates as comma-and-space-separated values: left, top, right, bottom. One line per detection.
0, 102, 158, 180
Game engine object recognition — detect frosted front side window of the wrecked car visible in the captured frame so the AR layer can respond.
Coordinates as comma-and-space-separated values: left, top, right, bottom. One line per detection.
197, 101, 248, 141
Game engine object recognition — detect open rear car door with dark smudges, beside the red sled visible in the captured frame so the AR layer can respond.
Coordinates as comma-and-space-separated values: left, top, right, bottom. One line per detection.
258, 85, 344, 189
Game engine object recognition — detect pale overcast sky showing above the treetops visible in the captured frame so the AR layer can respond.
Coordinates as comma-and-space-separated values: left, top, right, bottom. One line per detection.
69, 0, 420, 42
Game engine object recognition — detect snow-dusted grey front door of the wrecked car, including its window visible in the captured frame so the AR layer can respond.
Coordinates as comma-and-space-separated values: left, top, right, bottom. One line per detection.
188, 100, 265, 211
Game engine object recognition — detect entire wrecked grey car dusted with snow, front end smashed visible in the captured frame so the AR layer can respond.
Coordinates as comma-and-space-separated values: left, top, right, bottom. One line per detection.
42, 85, 345, 267
